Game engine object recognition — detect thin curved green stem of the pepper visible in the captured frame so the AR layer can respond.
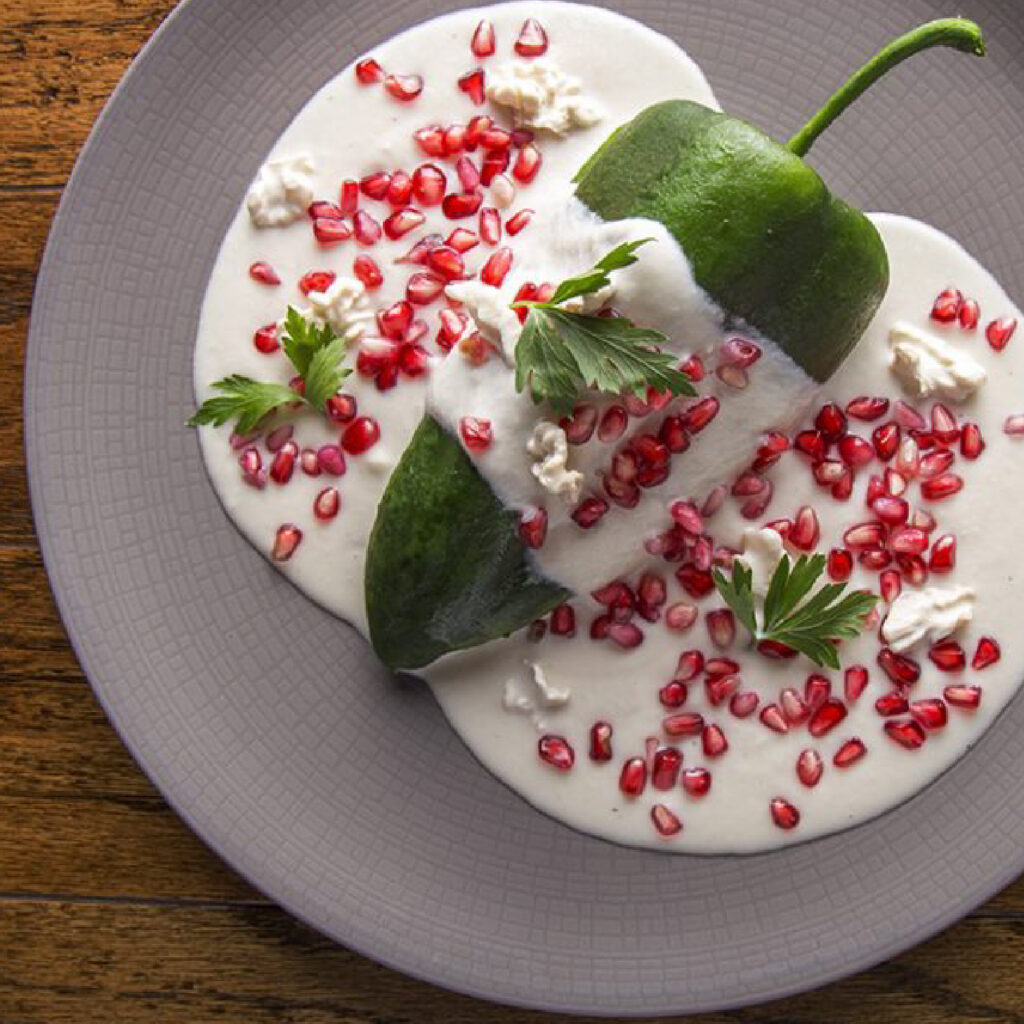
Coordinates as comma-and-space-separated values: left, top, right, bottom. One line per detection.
786, 17, 985, 157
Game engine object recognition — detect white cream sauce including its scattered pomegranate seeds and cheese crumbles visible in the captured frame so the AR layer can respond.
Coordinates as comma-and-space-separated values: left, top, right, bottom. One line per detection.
196, 3, 1024, 852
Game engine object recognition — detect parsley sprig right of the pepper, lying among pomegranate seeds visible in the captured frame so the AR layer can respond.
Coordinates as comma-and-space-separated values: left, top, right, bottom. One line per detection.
714, 555, 878, 669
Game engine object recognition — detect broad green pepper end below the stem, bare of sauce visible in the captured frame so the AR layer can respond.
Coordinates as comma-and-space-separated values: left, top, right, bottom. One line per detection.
577, 99, 889, 381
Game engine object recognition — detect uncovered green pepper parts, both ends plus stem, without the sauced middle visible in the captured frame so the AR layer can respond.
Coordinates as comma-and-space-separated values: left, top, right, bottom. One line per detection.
366, 18, 984, 669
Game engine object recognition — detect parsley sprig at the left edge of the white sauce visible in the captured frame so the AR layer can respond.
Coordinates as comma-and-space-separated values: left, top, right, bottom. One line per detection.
188, 306, 351, 434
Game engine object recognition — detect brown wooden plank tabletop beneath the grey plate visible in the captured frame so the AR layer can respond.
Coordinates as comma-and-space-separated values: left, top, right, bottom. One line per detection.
6, 0, 1024, 1024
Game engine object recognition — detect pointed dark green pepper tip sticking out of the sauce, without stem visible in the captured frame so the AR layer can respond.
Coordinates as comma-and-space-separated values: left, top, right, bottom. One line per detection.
366, 415, 571, 669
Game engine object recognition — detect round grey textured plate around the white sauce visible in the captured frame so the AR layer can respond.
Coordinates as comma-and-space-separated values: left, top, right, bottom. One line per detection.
26, 0, 1024, 1015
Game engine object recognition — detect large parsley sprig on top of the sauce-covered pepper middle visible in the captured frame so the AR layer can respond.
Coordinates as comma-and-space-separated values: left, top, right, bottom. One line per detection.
514, 239, 696, 414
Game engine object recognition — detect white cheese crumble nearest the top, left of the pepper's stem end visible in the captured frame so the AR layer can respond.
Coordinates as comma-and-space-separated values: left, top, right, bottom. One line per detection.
487, 59, 604, 135
